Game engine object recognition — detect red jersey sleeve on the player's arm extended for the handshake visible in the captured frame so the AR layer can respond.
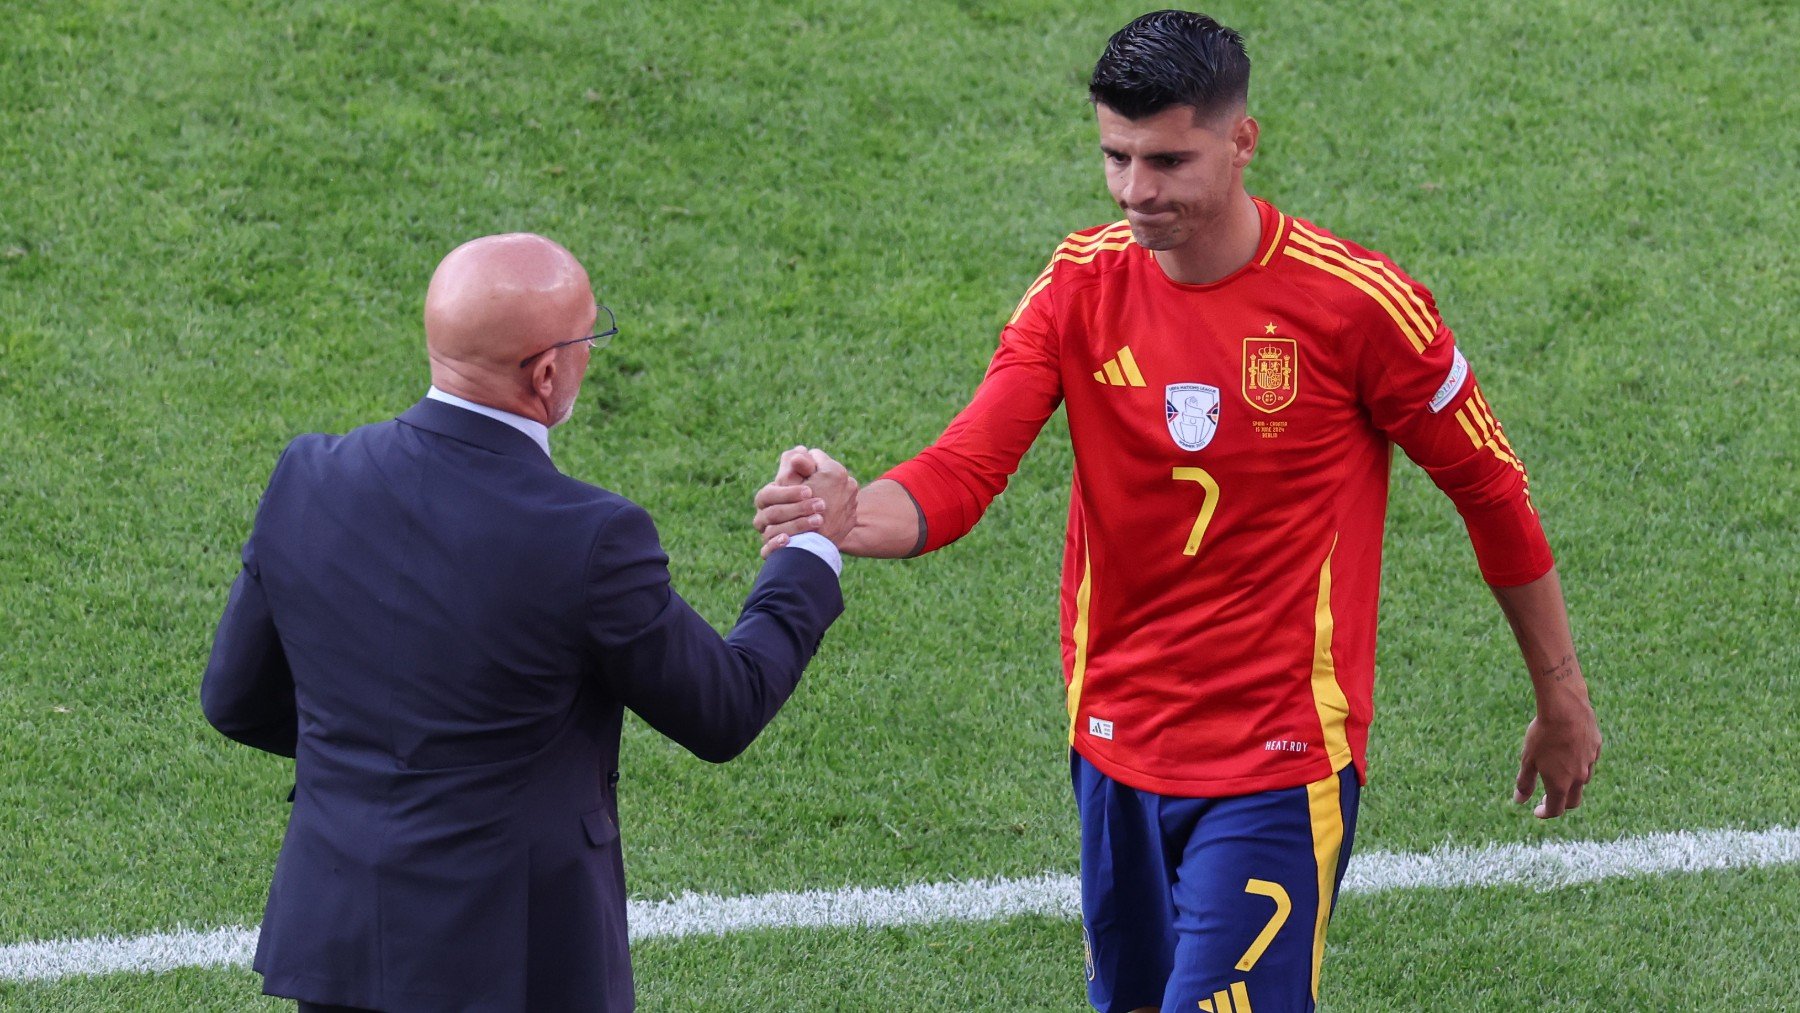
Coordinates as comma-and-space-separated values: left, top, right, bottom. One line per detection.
882, 261, 1062, 552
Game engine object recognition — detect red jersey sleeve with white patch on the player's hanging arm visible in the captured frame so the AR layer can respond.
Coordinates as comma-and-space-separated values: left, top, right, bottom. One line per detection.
1355, 255, 1555, 587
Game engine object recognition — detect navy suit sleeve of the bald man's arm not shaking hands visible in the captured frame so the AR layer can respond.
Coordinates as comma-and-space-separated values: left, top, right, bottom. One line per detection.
200, 464, 299, 756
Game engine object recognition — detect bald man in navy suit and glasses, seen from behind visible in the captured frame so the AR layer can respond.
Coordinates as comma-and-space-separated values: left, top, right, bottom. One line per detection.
200, 234, 855, 1013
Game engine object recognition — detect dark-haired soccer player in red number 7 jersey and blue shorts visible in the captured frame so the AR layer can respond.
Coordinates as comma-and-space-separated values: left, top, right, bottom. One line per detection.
756, 11, 1600, 1013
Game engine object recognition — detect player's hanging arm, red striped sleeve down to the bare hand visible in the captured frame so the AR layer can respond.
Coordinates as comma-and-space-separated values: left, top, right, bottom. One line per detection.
1352, 255, 1600, 819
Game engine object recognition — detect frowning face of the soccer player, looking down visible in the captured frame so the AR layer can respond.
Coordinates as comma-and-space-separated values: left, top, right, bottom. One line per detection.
1094, 103, 1256, 250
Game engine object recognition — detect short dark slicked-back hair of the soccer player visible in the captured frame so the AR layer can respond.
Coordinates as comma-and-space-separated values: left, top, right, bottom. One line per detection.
1087, 11, 1249, 119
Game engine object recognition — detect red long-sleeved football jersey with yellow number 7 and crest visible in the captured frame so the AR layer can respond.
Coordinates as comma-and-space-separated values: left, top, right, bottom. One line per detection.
887, 200, 1552, 795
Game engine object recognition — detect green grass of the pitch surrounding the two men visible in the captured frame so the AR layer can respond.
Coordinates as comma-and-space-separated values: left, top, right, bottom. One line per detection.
0, 0, 1800, 1009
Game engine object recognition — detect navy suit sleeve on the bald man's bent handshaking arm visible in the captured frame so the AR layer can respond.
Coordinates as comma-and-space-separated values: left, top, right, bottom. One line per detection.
587, 504, 844, 763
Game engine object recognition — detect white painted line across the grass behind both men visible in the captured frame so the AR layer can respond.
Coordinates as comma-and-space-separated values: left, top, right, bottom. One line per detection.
0, 828, 1800, 981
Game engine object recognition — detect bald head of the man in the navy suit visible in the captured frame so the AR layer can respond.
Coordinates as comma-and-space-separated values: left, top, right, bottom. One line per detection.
425, 232, 596, 425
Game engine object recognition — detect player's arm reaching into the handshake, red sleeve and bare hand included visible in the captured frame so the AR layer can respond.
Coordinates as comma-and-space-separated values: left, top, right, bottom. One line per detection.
754, 257, 1062, 558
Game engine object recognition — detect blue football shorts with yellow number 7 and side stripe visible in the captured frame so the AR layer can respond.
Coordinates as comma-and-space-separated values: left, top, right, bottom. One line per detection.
1069, 750, 1361, 1013
